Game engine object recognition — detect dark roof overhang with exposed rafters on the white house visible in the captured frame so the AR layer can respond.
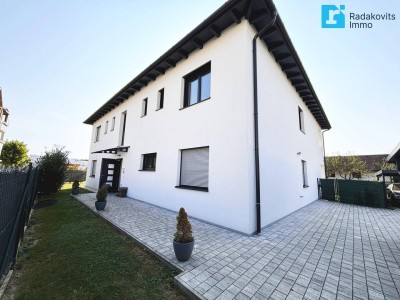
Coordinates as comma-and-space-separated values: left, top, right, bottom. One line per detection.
84, 0, 331, 129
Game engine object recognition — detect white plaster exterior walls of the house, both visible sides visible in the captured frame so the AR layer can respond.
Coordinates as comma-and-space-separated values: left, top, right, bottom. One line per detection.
87, 21, 324, 233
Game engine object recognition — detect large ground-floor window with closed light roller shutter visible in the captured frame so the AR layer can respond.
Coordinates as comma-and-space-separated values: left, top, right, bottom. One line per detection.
177, 147, 209, 191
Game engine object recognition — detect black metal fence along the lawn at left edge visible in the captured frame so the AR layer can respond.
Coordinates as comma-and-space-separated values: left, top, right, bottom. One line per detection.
0, 165, 39, 278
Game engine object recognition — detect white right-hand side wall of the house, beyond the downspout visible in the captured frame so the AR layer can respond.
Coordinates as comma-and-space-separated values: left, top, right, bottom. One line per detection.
252, 29, 324, 227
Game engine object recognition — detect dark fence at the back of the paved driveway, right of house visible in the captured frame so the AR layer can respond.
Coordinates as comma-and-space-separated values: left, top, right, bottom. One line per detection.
318, 179, 387, 208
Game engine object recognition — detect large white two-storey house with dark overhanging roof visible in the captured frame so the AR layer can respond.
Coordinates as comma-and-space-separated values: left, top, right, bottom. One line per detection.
84, 0, 331, 234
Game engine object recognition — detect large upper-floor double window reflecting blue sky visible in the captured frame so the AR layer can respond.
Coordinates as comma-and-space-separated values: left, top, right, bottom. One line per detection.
183, 62, 211, 107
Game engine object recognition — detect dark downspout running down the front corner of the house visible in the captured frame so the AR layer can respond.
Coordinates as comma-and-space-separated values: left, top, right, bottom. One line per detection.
253, 10, 278, 233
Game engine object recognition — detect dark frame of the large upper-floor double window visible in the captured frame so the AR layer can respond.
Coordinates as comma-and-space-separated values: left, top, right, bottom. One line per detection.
183, 61, 211, 108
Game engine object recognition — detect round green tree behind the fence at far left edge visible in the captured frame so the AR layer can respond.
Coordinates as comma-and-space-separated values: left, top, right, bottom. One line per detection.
0, 140, 30, 167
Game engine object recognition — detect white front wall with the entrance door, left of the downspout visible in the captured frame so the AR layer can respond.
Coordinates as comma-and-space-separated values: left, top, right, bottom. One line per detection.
87, 22, 254, 233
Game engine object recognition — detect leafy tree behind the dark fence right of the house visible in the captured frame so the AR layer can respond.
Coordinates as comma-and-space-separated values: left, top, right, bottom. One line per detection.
326, 154, 368, 180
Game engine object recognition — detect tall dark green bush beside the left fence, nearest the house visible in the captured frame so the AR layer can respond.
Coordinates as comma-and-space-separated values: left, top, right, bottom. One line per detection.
36, 147, 69, 194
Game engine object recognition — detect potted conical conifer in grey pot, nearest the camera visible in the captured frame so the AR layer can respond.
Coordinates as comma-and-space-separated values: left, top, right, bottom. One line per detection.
174, 207, 194, 261
